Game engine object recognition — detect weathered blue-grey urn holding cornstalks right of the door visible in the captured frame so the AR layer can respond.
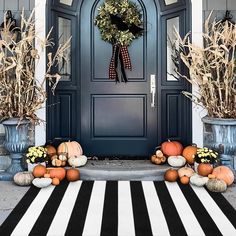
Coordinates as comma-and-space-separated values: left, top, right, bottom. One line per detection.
202, 116, 236, 171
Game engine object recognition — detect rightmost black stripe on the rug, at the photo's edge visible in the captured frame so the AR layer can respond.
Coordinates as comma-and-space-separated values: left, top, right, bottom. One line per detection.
206, 188, 236, 228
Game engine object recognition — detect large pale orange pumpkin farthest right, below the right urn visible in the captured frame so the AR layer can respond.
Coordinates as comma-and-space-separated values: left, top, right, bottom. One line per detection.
212, 166, 234, 186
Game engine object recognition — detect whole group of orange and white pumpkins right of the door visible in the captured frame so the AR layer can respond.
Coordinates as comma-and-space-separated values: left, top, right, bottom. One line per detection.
151, 140, 234, 192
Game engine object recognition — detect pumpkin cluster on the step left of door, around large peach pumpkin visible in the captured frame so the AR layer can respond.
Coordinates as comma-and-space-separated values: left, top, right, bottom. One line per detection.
46, 141, 87, 167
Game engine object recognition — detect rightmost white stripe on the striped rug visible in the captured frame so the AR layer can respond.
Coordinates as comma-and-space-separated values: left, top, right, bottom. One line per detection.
191, 185, 236, 236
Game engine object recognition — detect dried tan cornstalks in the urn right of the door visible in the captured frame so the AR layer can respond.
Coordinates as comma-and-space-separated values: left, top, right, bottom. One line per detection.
173, 14, 236, 119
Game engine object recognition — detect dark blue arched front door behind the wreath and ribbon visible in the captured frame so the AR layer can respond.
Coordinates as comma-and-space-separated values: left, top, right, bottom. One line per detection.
80, 0, 157, 157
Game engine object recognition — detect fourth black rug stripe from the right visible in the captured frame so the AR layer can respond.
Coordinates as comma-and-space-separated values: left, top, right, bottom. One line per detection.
130, 181, 152, 236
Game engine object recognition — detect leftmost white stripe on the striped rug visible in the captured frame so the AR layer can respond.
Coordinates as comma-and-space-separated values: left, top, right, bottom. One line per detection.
11, 185, 55, 236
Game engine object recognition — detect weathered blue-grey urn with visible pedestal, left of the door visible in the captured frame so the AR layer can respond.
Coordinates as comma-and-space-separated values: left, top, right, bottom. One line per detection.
0, 118, 30, 180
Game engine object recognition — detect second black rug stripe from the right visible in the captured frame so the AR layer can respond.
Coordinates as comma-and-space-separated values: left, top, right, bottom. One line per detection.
178, 182, 222, 236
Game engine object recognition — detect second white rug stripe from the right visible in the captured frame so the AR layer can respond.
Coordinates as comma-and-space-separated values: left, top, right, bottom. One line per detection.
165, 181, 205, 236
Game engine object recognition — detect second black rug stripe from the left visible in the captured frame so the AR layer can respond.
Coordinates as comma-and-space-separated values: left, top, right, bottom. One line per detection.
29, 180, 69, 236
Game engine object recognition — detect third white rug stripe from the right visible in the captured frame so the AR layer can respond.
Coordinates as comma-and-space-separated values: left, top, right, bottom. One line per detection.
142, 181, 170, 236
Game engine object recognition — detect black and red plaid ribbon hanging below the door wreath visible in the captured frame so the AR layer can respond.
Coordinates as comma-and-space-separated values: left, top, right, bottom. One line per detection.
109, 44, 132, 82
